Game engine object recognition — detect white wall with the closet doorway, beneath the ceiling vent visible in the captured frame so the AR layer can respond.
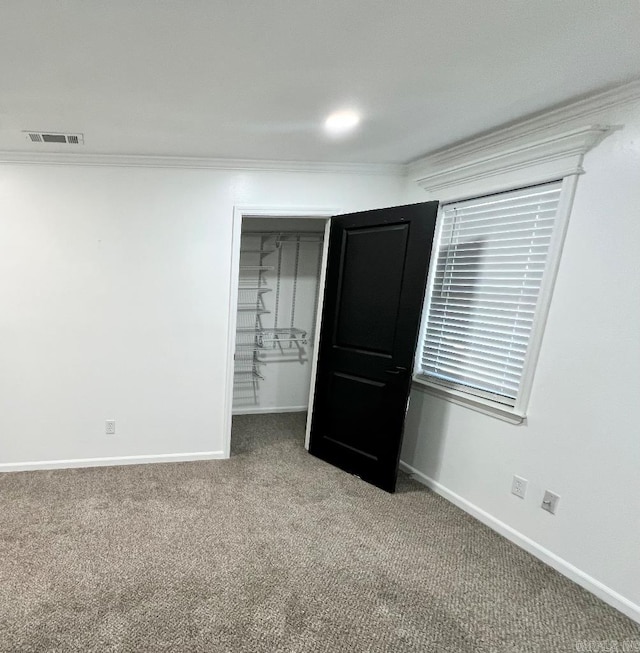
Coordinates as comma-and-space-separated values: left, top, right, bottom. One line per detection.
0, 165, 401, 470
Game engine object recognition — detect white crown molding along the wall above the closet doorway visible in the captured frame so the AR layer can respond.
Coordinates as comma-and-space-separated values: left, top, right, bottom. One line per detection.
0, 151, 406, 177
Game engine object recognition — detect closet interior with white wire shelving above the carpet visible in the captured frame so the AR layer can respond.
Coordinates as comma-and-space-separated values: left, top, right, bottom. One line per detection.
233, 218, 325, 415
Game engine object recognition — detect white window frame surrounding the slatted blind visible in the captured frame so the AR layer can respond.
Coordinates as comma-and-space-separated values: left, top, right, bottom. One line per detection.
413, 174, 578, 424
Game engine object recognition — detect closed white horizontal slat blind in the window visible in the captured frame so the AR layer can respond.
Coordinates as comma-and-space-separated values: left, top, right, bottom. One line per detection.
420, 182, 562, 406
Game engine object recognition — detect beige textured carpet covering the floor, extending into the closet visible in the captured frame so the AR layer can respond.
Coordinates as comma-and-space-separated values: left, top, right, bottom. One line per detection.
0, 415, 640, 653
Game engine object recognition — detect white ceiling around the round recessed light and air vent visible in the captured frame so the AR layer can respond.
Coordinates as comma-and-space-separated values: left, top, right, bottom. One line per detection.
0, 0, 640, 163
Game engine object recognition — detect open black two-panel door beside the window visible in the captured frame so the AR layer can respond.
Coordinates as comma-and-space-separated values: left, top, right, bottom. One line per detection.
309, 202, 438, 492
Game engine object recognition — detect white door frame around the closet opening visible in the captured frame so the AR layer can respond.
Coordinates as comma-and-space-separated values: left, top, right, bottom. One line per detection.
223, 205, 343, 458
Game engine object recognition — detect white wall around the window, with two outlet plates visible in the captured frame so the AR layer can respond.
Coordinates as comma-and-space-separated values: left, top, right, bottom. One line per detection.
402, 99, 640, 620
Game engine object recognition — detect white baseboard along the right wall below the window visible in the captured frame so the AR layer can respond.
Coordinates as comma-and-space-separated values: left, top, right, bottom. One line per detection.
400, 461, 640, 623
